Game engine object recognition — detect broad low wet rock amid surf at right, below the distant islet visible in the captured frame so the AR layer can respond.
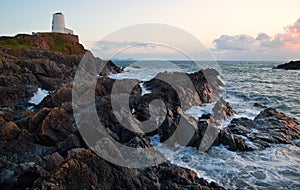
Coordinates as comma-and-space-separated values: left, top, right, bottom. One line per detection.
227, 108, 300, 149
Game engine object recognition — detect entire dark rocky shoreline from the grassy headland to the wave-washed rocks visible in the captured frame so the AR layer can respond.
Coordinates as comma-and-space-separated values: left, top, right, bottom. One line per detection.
0, 34, 300, 189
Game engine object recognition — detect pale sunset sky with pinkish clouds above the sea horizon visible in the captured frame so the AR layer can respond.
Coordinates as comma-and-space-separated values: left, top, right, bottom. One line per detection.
0, 0, 300, 61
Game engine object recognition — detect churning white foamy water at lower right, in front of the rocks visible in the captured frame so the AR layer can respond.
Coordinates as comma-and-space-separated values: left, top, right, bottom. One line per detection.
152, 145, 300, 189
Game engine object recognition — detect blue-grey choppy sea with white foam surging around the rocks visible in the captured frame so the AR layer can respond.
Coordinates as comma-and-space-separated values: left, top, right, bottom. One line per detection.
110, 61, 300, 189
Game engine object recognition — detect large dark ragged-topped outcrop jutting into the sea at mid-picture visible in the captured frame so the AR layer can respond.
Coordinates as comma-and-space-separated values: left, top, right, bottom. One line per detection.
143, 69, 224, 109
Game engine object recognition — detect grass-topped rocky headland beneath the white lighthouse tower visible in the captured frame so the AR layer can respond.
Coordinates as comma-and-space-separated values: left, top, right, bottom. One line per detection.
0, 33, 122, 105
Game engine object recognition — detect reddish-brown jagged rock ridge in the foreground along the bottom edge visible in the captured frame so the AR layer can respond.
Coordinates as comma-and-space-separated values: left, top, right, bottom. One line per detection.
34, 149, 223, 189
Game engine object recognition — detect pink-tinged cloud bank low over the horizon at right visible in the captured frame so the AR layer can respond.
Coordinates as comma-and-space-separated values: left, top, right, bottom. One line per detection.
212, 19, 300, 52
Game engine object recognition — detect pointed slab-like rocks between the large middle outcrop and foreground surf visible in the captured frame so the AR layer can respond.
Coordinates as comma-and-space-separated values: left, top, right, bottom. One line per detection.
158, 98, 237, 151
